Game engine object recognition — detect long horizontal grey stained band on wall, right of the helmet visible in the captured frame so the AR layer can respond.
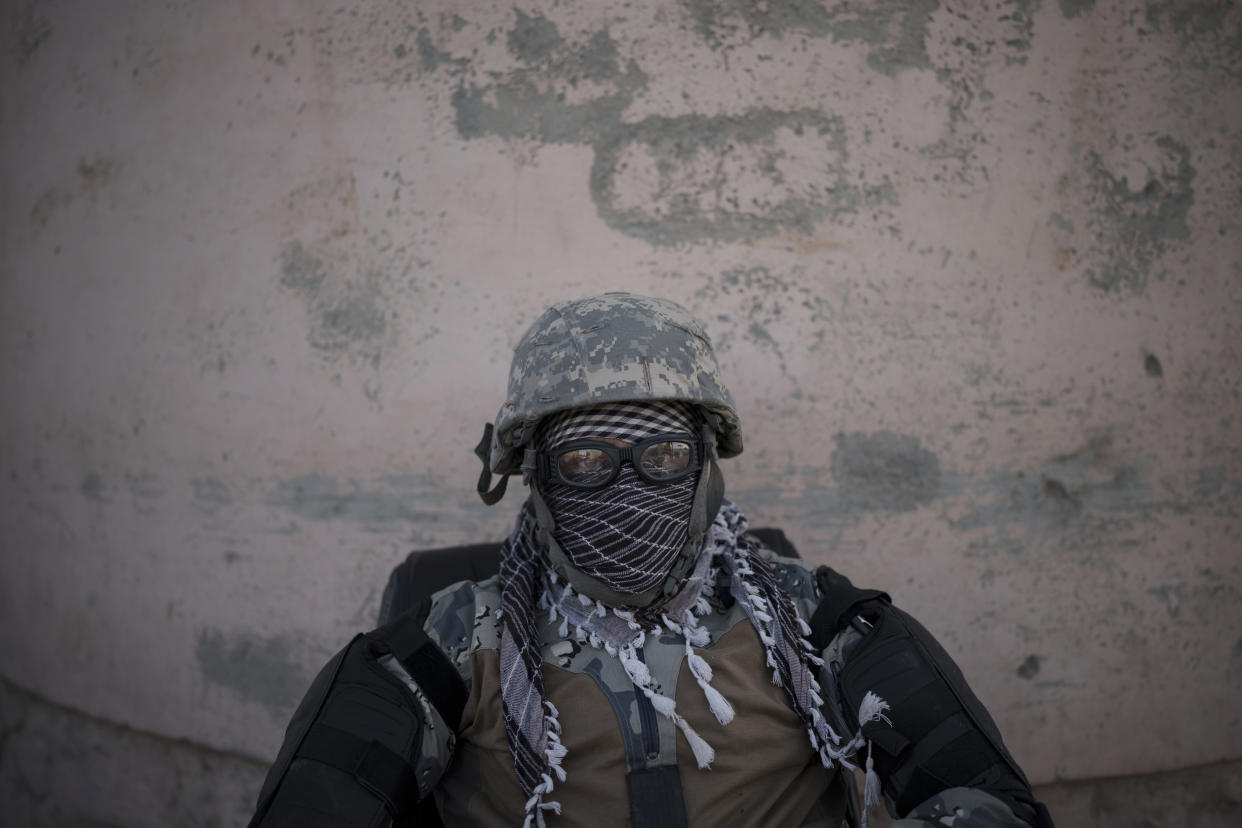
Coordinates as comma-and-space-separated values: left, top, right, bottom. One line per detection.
730, 432, 1242, 553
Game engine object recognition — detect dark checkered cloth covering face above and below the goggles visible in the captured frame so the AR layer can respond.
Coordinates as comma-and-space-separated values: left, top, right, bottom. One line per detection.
537, 401, 699, 595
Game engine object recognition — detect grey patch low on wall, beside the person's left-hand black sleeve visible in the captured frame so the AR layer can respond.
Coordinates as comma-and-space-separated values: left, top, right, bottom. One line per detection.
194, 629, 312, 719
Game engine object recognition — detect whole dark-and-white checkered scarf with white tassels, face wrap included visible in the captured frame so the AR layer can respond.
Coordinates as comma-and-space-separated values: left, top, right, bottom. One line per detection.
499, 403, 888, 828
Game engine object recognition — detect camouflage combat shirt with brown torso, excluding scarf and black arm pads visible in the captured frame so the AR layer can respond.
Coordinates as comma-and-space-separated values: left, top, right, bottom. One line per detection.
406, 546, 1025, 828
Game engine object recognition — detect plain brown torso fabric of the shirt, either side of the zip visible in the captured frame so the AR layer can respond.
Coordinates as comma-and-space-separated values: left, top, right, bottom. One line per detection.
437, 623, 840, 828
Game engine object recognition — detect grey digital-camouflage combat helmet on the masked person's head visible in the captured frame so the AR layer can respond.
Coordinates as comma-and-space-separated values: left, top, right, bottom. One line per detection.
489, 293, 741, 474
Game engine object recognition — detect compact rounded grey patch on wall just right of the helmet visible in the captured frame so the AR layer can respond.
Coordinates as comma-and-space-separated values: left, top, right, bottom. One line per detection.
832, 431, 940, 511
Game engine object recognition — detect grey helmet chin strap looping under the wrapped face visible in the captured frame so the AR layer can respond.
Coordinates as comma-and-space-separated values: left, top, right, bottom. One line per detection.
522, 423, 724, 608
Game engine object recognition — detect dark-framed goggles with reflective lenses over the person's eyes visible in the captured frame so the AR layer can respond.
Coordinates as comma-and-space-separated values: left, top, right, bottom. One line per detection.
538, 434, 703, 489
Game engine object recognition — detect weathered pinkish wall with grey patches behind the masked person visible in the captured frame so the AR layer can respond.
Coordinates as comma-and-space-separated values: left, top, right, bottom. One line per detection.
0, 0, 1242, 826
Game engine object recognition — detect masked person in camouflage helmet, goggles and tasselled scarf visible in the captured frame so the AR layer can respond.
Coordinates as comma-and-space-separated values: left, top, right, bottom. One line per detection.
251, 293, 1052, 828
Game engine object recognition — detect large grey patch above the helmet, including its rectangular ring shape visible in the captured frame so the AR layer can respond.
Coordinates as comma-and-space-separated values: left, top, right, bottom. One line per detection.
452, 17, 894, 245
